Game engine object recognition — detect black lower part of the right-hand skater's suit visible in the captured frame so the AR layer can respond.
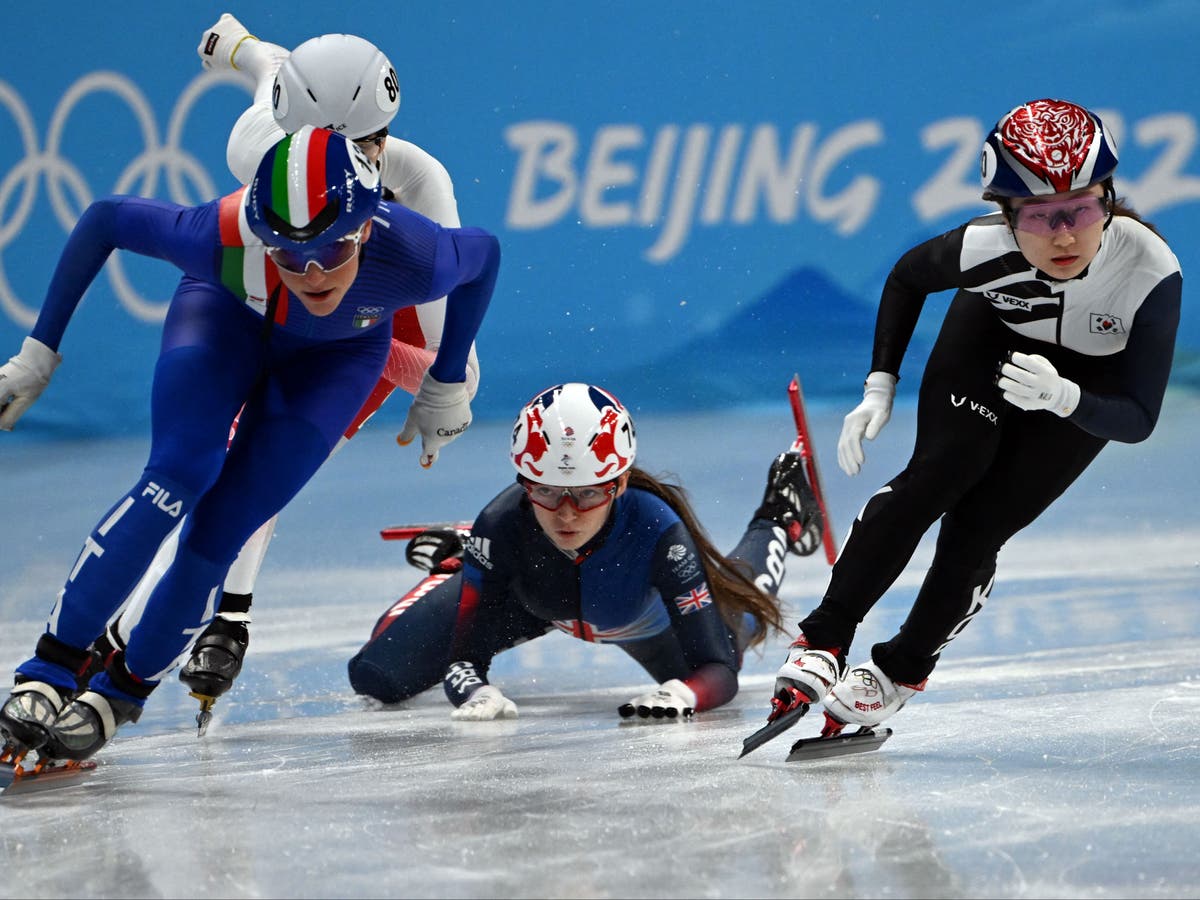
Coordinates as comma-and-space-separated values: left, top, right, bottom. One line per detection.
800, 292, 1111, 684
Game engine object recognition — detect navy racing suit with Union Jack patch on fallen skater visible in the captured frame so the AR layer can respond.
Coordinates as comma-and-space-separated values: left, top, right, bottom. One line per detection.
349, 485, 786, 712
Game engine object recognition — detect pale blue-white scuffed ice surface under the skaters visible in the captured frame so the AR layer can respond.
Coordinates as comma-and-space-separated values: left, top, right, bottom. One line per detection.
0, 398, 1200, 898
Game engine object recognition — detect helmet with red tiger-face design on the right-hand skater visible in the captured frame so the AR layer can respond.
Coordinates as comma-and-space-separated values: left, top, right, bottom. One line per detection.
979, 100, 1117, 200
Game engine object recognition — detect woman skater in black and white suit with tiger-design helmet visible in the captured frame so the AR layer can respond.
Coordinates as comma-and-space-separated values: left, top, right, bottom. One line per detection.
772, 100, 1182, 736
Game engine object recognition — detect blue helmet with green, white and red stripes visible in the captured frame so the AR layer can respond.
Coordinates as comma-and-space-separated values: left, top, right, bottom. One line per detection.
242, 125, 383, 254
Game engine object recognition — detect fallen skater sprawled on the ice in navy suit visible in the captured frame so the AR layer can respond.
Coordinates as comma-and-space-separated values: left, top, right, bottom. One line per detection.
349, 383, 823, 724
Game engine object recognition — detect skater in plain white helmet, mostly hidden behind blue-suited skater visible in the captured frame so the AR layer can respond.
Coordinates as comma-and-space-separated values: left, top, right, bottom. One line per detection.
98, 13, 479, 730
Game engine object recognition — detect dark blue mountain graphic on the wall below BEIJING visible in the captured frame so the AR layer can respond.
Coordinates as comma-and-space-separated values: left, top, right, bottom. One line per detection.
612, 266, 930, 412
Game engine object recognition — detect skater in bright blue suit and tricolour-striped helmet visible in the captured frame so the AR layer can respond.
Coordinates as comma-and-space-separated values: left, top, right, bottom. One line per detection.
0, 126, 499, 760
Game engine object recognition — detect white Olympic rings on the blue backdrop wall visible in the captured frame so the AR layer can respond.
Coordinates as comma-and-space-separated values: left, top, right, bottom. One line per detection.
0, 71, 248, 328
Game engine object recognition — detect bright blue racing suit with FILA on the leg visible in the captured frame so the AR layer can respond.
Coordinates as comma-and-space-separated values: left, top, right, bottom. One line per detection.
17, 188, 499, 701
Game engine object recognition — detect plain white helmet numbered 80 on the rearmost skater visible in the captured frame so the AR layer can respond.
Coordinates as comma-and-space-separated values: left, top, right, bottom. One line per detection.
271, 35, 400, 140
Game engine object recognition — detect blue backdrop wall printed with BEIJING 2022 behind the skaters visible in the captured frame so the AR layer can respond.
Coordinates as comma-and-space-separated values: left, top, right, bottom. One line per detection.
0, 0, 1200, 437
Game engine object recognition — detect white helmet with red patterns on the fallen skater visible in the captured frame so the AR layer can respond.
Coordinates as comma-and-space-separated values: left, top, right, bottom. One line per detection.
510, 382, 637, 487
